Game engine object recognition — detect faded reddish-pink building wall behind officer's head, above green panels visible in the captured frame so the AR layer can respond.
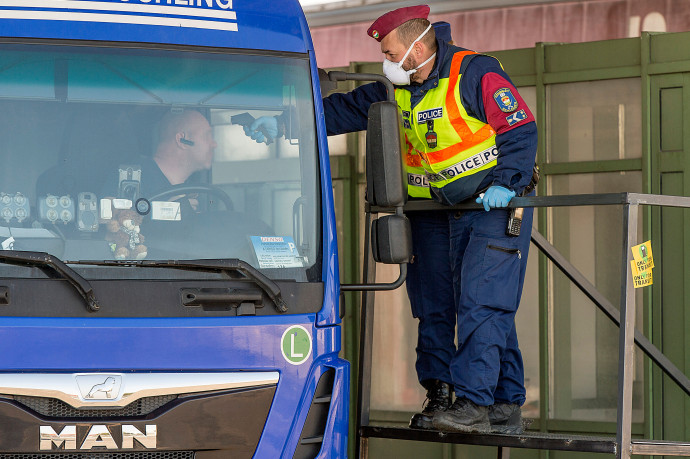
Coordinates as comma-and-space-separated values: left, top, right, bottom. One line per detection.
312, 0, 690, 68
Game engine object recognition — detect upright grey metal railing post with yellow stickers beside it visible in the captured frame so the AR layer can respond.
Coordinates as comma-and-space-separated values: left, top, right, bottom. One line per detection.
616, 203, 639, 459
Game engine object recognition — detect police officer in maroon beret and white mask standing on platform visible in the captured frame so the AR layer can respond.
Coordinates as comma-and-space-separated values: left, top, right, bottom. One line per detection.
247, 5, 537, 433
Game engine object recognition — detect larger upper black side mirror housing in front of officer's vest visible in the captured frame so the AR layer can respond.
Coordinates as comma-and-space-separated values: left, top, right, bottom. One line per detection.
367, 101, 407, 207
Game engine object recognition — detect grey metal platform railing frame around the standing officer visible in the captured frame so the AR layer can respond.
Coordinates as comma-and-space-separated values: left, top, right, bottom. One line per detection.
356, 193, 690, 459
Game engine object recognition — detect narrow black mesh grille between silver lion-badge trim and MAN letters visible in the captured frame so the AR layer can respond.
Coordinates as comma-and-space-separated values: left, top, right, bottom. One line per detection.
12, 395, 177, 420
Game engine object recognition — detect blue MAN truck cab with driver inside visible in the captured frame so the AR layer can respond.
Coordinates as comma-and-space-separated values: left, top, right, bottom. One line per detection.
0, 0, 409, 459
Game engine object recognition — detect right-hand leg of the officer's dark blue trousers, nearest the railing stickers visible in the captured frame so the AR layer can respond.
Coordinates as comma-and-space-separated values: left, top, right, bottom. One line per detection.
448, 208, 533, 406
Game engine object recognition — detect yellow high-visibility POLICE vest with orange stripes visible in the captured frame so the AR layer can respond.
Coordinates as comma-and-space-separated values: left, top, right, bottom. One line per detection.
395, 51, 498, 198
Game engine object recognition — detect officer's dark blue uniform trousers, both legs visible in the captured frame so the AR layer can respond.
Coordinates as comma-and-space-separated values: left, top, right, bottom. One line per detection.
406, 208, 532, 406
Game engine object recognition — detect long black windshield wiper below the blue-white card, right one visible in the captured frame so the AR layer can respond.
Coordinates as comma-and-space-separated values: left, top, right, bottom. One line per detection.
65, 258, 287, 312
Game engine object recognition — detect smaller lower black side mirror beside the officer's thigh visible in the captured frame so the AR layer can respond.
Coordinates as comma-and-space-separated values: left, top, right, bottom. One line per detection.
371, 215, 412, 265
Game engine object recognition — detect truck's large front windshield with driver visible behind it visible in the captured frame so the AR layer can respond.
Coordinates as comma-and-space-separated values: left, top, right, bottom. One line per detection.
0, 45, 321, 281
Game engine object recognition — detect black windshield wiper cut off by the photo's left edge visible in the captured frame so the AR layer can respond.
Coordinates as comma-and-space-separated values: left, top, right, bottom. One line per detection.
0, 250, 101, 312
